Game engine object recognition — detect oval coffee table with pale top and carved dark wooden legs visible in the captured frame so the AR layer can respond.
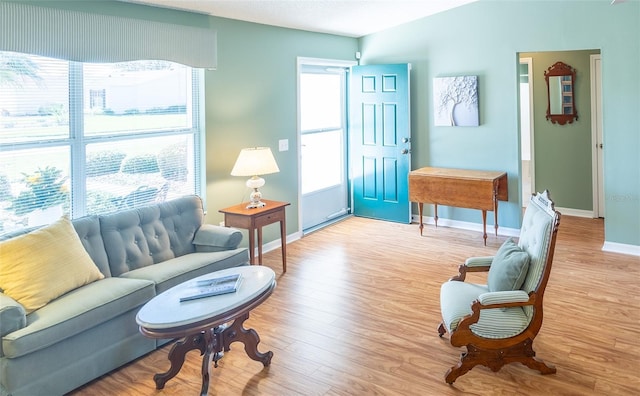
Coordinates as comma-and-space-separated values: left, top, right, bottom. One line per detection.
136, 265, 276, 395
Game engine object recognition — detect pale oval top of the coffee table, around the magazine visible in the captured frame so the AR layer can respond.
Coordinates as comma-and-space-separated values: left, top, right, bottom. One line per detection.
136, 265, 275, 330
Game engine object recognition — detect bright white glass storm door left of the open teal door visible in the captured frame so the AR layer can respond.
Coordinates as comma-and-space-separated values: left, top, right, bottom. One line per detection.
298, 58, 355, 234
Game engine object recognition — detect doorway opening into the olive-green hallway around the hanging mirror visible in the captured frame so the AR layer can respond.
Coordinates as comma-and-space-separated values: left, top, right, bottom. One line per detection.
517, 49, 604, 218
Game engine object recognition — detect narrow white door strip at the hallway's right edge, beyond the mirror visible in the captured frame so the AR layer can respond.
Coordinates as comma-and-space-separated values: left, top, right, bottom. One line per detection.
589, 54, 605, 218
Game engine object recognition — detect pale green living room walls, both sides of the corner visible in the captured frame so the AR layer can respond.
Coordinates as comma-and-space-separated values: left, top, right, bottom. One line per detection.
21, 0, 640, 245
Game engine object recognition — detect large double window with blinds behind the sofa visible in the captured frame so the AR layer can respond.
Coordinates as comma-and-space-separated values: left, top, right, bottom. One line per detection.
0, 51, 201, 234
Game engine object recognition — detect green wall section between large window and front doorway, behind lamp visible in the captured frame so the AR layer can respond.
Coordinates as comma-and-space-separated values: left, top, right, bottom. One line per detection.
205, 17, 358, 241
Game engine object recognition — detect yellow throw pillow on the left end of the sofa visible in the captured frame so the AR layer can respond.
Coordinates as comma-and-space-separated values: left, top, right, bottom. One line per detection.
0, 216, 104, 313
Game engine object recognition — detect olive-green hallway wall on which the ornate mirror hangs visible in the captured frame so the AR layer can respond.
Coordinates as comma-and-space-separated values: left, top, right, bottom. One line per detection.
520, 50, 600, 212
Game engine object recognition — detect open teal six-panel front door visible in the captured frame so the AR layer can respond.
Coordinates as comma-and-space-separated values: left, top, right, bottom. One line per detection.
349, 64, 411, 223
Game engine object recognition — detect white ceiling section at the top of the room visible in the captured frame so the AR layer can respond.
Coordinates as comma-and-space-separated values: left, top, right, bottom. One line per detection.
124, 0, 476, 37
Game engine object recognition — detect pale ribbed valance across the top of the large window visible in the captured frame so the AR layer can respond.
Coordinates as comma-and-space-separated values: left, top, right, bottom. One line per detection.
0, 2, 217, 69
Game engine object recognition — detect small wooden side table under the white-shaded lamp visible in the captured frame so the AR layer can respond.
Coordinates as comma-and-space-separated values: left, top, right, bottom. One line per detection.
219, 199, 290, 272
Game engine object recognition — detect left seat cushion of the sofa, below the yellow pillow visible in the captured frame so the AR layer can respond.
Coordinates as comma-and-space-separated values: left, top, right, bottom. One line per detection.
2, 278, 155, 358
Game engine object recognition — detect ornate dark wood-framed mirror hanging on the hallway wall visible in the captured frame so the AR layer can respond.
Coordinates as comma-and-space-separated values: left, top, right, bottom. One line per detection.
544, 62, 578, 125
